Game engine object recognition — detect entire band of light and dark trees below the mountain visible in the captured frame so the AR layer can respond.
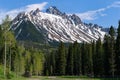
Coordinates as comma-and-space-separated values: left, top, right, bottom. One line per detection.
0, 16, 120, 77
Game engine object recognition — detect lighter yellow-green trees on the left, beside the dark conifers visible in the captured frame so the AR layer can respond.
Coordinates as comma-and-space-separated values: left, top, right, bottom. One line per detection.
0, 16, 44, 78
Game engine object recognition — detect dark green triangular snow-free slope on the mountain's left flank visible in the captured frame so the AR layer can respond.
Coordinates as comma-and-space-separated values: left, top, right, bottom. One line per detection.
15, 21, 45, 42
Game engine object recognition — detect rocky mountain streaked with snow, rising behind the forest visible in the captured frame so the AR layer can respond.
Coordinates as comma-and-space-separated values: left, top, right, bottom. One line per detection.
11, 6, 105, 43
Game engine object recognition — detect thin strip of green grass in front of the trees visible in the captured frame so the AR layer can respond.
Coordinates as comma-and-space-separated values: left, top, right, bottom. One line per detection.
0, 76, 120, 80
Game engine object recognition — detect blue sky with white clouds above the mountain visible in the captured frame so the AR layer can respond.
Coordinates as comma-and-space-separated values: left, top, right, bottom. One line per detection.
0, 0, 120, 27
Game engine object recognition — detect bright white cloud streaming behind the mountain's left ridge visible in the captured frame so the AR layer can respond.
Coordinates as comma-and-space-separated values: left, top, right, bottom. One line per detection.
0, 2, 48, 23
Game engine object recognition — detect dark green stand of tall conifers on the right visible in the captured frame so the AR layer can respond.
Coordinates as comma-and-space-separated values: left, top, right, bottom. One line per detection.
44, 21, 120, 77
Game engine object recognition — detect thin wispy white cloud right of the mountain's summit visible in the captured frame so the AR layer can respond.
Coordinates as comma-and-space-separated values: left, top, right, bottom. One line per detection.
76, 1, 120, 20
